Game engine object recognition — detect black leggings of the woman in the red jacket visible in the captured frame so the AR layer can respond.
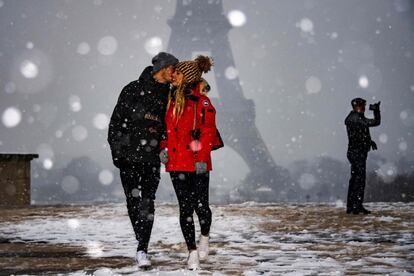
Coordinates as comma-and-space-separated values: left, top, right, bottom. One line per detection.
170, 172, 211, 251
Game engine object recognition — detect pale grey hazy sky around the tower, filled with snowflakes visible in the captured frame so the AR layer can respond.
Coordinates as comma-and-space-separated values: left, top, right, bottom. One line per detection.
0, 0, 414, 203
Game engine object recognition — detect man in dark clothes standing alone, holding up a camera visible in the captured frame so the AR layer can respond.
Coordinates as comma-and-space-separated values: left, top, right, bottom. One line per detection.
345, 98, 381, 214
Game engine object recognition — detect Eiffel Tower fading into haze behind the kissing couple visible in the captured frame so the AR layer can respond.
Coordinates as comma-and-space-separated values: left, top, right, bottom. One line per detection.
168, 0, 289, 200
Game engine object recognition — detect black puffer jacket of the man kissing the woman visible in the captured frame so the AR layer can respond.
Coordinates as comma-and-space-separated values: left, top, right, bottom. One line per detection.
108, 66, 169, 168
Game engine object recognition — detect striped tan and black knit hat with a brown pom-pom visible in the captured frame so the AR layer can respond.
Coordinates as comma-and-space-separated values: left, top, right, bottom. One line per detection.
175, 56, 213, 83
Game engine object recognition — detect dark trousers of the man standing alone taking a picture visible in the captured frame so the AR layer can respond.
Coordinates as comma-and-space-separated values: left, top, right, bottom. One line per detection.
346, 152, 367, 211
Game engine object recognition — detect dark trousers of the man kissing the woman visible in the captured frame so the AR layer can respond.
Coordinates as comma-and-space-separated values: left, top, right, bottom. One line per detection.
120, 163, 160, 252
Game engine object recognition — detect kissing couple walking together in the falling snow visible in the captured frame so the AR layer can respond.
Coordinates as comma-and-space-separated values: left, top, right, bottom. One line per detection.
108, 52, 223, 270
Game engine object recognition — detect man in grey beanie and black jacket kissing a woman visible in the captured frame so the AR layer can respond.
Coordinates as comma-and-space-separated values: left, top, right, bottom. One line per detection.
108, 52, 178, 267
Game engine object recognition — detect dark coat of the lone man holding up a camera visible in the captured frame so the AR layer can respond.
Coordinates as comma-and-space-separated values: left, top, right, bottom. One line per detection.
345, 110, 381, 153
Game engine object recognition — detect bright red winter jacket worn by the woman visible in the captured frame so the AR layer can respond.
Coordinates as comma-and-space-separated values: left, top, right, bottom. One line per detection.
161, 84, 217, 172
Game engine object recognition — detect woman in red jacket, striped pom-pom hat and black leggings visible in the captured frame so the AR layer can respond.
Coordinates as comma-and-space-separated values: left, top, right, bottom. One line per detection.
160, 56, 217, 269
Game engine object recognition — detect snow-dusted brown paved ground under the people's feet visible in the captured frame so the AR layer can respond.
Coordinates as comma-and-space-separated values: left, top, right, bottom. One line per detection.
0, 203, 414, 275
